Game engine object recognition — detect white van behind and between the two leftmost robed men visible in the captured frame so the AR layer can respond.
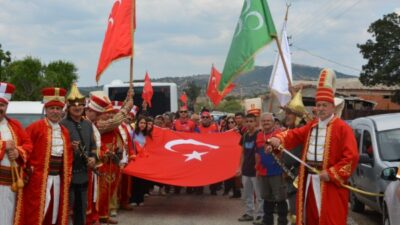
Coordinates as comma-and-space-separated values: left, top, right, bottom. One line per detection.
7, 101, 44, 127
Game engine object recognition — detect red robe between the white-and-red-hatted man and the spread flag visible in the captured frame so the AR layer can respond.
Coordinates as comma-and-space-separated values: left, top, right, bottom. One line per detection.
98, 127, 123, 219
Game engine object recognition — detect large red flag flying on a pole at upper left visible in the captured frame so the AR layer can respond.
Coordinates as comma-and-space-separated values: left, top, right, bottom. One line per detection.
96, 0, 136, 82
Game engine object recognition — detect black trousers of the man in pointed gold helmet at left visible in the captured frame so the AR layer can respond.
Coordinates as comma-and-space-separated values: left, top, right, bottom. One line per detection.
69, 183, 88, 225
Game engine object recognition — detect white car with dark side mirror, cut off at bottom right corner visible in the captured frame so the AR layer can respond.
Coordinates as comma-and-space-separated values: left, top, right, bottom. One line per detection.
382, 167, 400, 225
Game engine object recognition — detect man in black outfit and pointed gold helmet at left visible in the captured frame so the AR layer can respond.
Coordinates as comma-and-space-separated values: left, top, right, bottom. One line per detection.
61, 83, 96, 225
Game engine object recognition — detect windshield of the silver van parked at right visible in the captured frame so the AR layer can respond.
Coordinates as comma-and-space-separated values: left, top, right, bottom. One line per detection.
378, 128, 400, 161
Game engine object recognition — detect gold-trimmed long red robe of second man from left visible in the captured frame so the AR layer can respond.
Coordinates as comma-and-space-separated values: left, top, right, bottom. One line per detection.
23, 119, 73, 225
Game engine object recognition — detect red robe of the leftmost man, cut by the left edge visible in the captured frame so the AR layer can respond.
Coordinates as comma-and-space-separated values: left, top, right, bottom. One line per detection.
0, 118, 32, 224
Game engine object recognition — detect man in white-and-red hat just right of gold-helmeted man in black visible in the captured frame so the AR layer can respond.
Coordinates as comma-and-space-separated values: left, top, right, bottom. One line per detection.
85, 91, 110, 225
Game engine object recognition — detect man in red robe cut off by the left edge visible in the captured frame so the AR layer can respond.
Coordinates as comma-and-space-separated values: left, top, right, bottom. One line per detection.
0, 82, 32, 225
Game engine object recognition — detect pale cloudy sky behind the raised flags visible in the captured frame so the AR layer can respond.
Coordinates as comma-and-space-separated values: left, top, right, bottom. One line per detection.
0, 0, 400, 86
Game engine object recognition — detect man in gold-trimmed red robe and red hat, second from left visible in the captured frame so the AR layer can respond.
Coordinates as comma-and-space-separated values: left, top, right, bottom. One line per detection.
21, 88, 73, 225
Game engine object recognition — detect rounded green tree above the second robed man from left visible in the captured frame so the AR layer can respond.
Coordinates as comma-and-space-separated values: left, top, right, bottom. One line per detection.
44, 60, 78, 89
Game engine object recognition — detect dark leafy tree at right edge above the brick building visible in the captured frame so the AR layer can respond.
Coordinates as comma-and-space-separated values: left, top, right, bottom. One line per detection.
357, 13, 400, 100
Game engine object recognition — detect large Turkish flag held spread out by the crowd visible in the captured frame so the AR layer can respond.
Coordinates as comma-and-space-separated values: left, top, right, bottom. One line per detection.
123, 127, 241, 187
